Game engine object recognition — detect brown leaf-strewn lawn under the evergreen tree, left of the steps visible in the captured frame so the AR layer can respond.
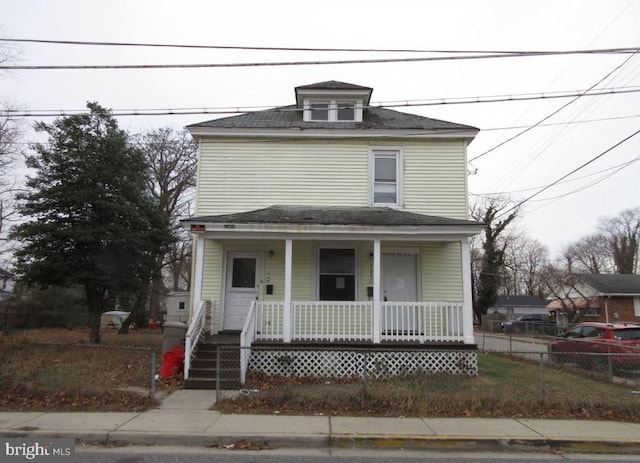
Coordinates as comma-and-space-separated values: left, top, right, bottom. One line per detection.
0, 328, 181, 411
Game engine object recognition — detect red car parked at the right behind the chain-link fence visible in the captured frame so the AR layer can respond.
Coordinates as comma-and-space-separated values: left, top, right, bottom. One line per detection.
549, 322, 640, 372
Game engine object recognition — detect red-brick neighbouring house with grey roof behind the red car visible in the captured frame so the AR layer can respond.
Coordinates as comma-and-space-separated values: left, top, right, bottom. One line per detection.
547, 274, 640, 323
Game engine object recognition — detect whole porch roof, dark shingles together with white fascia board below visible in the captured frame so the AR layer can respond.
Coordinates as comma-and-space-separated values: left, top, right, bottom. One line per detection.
182, 205, 482, 239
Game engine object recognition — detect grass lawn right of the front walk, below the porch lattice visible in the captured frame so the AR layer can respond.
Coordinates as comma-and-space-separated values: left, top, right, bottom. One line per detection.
216, 353, 640, 422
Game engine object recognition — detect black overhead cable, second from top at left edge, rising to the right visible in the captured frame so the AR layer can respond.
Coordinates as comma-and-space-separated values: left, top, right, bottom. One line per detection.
0, 48, 640, 71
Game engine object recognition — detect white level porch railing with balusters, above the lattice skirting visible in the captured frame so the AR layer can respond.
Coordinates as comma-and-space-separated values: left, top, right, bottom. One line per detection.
243, 301, 464, 347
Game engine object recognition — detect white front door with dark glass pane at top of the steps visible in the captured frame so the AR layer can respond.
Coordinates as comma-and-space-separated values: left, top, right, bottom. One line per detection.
223, 252, 260, 331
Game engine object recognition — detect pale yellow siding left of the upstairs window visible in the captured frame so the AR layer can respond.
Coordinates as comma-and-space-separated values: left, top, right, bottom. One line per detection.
196, 141, 368, 215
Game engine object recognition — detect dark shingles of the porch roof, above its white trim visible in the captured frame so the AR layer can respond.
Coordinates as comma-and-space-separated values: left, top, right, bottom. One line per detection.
185, 205, 480, 226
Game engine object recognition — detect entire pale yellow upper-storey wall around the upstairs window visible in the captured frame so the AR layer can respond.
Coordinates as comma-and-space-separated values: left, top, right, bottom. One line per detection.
195, 138, 467, 219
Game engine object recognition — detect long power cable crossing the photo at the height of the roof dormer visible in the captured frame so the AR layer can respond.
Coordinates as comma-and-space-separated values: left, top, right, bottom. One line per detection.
6, 86, 640, 118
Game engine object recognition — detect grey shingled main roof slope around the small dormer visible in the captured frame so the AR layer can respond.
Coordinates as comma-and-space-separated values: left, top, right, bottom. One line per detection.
189, 105, 478, 134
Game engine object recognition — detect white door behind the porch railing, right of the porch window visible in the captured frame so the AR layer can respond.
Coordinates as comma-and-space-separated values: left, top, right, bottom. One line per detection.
382, 253, 418, 334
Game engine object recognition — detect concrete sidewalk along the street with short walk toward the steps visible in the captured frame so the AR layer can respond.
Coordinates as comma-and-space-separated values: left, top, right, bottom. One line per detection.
0, 390, 640, 454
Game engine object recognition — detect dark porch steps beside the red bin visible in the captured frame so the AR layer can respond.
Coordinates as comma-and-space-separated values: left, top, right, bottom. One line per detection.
184, 333, 240, 390
